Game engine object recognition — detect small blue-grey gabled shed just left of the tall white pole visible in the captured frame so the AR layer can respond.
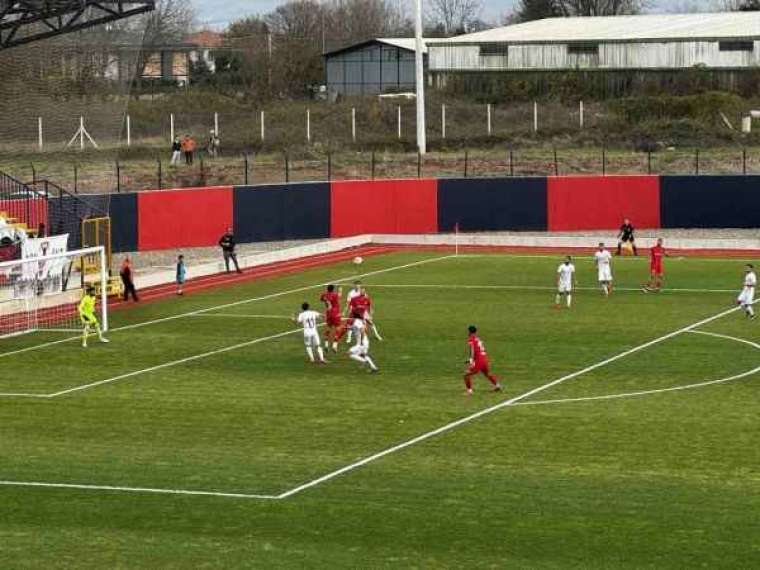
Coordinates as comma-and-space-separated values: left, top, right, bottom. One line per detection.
324, 38, 428, 95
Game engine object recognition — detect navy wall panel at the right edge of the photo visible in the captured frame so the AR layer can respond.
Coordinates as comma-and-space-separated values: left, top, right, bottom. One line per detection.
660, 176, 760, 228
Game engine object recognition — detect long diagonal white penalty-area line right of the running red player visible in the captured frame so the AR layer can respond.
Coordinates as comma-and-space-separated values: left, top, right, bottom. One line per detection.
278, 307, 741, 499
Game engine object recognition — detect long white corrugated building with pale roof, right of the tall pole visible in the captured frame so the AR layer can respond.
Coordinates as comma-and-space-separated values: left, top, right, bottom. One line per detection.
428, 12, 760, 91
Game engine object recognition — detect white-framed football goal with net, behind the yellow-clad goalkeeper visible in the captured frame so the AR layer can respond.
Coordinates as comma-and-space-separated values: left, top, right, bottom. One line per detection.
0, 246, 108, 338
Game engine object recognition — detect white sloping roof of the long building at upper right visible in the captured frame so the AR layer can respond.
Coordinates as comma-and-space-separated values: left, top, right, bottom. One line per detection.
427, 12, 760, 44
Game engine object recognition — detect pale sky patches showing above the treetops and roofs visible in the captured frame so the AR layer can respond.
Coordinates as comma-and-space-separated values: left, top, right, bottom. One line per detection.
193, 0, 711, 28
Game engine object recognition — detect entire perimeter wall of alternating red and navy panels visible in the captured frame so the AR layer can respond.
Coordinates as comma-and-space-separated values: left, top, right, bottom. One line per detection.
49, 176, 760, 252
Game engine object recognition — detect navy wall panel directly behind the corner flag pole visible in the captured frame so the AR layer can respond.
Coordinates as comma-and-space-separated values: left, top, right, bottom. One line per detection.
438, 177, 547, 232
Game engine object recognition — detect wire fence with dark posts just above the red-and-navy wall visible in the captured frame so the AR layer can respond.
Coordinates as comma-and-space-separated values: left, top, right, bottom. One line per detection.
2, 147, 760, 193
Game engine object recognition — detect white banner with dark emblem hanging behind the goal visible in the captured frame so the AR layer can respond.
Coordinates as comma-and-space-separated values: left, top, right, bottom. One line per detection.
17, 234, 69, 298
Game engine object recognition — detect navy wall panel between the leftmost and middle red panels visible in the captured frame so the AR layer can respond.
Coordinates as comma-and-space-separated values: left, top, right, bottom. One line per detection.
233, 182, 330, 243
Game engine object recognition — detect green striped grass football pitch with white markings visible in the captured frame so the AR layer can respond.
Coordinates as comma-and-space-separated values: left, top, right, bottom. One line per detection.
0, 250, 760, 568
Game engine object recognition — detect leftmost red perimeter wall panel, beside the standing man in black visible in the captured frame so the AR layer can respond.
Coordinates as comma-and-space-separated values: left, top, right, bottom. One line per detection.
137, 186, 232, 251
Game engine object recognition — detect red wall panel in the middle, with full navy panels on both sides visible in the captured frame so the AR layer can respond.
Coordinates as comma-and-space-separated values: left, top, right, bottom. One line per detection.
330, 179, 438, 237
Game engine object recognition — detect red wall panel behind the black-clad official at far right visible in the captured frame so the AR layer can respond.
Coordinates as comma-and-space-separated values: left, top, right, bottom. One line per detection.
547, 176, 660, 231
